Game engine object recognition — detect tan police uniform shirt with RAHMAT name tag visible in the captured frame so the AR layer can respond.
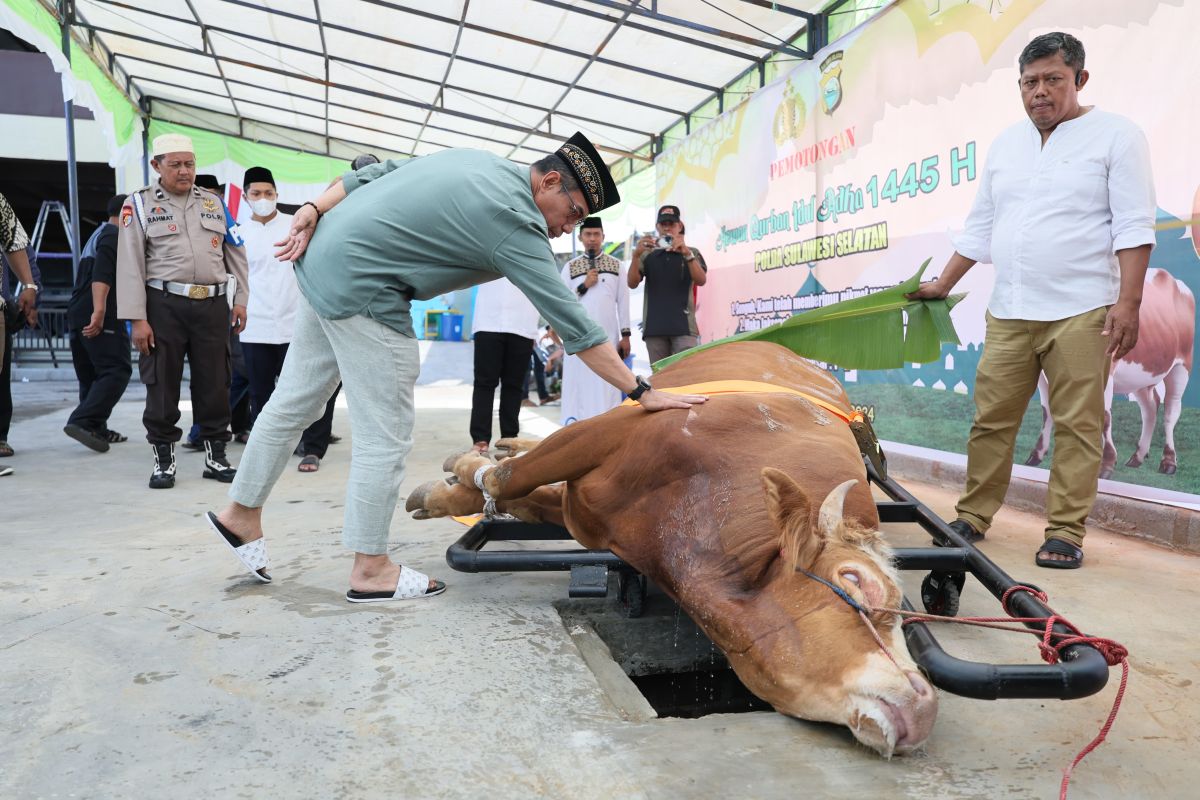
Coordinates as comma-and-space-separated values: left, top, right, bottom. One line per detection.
116, 184, 248, 319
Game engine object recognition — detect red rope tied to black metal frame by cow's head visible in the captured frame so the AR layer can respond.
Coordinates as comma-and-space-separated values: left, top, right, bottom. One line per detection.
864, 585, 1129, 800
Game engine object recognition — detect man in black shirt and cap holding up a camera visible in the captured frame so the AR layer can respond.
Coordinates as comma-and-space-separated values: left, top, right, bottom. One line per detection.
629, 205, 708, 363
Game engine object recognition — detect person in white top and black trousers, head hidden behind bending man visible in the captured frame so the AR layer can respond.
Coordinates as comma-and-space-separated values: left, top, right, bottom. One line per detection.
470, 278, 538, 453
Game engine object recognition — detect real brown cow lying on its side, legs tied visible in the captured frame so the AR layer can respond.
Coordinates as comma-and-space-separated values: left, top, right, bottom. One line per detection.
407, 342, 937, 756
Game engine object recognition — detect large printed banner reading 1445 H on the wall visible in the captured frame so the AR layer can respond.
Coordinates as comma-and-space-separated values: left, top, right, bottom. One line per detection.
656, 0, 1200, 504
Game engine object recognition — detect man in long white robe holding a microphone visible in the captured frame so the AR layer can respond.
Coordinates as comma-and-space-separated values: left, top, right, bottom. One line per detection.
562, 217, 629, 425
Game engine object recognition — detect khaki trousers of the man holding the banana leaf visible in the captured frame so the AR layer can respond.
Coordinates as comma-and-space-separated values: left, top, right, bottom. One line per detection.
955, 306, 1111, 545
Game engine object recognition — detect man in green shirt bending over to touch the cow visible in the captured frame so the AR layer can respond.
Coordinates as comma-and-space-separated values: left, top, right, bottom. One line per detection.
206, 133, 704, 602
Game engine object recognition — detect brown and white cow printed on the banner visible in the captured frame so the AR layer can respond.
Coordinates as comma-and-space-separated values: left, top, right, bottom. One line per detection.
1025, 269, 1196, 477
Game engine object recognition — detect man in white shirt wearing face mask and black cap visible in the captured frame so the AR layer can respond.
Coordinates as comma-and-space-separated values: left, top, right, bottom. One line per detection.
241, 167, 331, 473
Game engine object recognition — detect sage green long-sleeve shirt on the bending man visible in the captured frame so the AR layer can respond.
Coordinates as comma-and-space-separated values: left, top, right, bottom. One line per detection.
296, 150, 608, 353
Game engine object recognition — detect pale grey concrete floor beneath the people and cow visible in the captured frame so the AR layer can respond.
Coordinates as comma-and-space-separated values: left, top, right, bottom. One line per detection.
0, 380, 1200, 800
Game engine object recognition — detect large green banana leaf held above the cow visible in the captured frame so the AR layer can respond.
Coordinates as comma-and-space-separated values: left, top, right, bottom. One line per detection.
654, 259, 966, 372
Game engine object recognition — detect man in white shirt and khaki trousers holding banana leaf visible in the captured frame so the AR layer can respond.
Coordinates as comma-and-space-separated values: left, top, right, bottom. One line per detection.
912, 32, 1156, 569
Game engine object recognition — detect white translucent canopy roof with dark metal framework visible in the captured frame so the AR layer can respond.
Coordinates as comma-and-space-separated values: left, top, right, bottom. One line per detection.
73, 0, 840, 163
